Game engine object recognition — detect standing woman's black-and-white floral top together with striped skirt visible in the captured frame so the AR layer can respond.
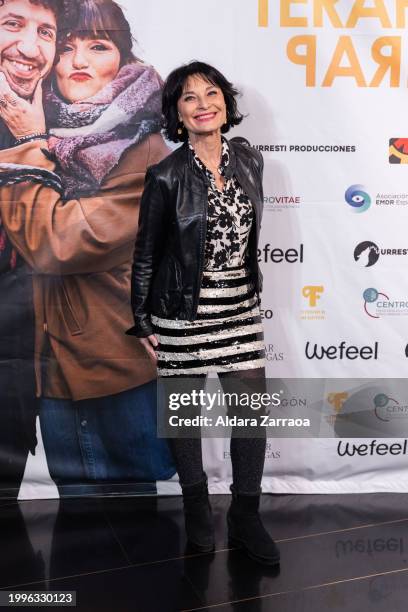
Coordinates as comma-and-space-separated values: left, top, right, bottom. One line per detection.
152, 139, 265, 376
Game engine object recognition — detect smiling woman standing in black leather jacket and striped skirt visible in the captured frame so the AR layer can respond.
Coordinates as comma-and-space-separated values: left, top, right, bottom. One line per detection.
131, 62, 279, 564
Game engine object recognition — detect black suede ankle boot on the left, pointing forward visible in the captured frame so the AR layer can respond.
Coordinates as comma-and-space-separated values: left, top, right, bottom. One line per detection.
182, 478, 215, 553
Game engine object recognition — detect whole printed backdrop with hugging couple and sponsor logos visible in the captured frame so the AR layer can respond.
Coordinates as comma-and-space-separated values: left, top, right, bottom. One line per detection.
0, 0, 408, 499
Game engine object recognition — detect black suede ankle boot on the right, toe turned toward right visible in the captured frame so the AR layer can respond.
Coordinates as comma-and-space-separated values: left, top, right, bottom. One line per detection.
227, 487, 280, 565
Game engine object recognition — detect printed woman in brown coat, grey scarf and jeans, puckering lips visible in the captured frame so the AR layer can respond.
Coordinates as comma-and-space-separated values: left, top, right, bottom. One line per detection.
0, 0, 174, 495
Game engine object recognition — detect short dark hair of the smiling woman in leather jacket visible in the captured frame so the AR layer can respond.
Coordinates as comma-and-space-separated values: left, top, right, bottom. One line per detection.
162, 61, 243, 142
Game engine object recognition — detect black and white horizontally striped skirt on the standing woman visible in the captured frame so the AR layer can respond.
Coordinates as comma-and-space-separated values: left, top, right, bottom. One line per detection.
152, 267, 265, 376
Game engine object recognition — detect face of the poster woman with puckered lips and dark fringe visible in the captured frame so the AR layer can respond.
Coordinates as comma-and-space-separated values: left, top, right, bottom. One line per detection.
55, 38, 120, 102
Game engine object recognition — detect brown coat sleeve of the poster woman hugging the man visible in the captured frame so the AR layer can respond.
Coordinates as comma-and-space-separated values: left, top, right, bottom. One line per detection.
0, 140, 164, 275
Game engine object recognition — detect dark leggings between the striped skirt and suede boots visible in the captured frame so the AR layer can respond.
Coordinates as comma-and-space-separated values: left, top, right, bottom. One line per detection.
170, 368, 266, 495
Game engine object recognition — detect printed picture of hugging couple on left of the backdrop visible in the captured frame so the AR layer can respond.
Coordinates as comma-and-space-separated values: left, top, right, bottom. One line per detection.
0, 0, 175, 497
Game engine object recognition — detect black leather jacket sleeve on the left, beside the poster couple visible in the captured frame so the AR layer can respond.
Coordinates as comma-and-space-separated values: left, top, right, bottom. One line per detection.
126, 169, 168, 338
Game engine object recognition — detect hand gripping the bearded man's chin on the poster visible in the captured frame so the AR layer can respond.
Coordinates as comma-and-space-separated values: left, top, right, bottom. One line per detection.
0, 72, 46, 139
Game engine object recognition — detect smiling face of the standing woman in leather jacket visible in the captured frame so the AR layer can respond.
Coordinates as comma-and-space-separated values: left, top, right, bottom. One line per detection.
177, 75, 227, 135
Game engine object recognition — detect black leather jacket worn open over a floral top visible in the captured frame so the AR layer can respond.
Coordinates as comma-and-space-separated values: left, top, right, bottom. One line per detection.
127, 139, 263, 338
